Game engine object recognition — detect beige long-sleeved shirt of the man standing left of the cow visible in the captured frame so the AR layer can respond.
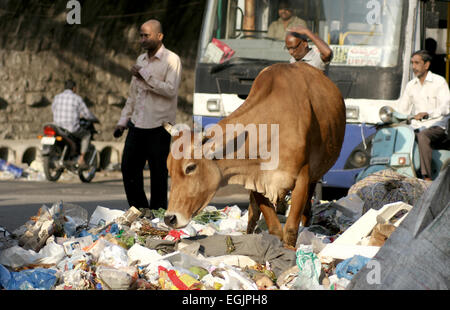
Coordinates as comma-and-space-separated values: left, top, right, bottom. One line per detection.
118, 45, 185, 129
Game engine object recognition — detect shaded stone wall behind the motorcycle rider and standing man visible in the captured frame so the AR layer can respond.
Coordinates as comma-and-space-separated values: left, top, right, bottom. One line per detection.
0, 0, 202, 142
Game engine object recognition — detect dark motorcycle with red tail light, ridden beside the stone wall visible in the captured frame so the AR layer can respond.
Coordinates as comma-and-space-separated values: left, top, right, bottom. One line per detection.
39, 119, 98, 183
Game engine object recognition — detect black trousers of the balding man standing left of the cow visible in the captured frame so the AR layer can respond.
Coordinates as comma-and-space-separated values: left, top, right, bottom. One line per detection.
122, 127, 171, 210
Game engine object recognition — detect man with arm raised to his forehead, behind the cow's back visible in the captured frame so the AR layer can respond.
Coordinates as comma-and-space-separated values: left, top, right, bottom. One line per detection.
285, 26, 333, 71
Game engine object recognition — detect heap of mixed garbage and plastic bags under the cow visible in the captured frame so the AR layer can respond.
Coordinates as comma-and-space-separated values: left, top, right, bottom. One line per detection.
0, 186, 418, 290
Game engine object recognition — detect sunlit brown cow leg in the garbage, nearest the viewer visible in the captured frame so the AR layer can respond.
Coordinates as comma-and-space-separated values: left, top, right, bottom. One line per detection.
283, 165, 309, 247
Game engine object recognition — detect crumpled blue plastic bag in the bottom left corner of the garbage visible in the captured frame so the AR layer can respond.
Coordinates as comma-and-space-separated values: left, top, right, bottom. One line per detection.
0, 265, 57, 290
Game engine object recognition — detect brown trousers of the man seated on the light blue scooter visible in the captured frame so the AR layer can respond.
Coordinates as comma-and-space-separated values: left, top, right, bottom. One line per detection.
416, 126, 446, 178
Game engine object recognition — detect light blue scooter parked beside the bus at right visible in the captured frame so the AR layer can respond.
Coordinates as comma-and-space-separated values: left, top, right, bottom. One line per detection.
356, 106, 450, 182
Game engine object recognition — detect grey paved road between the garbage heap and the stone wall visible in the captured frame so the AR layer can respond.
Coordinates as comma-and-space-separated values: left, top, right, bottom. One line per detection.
0, 172, 248, 232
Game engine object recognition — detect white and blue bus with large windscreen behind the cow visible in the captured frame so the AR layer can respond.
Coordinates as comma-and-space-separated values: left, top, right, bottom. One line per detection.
193, 0, 450, 195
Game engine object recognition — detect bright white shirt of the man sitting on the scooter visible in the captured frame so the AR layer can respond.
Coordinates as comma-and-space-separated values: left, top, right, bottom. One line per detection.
398, 71, 450, 130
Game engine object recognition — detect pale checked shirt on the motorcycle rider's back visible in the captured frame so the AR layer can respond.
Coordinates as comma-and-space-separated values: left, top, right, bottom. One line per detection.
52, 89, 95, 132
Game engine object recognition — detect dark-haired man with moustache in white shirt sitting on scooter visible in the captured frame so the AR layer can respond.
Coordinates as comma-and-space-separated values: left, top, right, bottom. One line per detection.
398, 50, 450, 180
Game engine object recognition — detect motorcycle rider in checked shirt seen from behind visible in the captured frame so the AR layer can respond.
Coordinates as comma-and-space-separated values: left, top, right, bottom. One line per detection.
52, 80, 98, 169
